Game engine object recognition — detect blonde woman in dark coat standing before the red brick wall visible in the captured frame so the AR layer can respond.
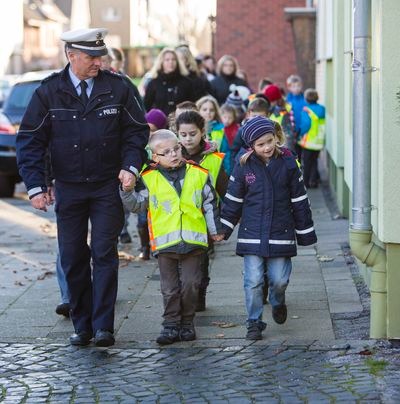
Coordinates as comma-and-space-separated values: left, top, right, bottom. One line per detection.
210, 55, 248, 105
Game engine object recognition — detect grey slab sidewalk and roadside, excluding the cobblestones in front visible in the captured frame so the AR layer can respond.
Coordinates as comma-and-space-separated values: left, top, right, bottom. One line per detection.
0, 183, 363, 346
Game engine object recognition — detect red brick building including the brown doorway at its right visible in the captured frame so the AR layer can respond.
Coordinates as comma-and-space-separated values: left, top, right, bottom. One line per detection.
215, 0, 315, 90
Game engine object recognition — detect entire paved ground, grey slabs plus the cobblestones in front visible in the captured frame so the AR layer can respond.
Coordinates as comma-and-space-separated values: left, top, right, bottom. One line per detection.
0, 185, 400, 403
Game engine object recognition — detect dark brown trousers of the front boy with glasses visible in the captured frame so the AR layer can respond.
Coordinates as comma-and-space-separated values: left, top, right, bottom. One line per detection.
157, 249, 204, 327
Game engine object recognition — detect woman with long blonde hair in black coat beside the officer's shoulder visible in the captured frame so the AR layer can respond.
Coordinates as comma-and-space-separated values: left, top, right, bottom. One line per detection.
144, 48, 195, 116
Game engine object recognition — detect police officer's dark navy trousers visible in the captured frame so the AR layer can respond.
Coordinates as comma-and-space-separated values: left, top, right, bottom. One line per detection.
55, 180, 124, 333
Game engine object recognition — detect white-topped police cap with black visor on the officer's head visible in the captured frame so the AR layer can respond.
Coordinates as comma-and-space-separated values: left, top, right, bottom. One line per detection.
61, 28, 108, 56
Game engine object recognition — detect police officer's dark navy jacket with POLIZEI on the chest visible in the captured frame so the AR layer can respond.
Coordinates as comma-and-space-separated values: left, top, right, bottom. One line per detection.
17, 65, 149, 196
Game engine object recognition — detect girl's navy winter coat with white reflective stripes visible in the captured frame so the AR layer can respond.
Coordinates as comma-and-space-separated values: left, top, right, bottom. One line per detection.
221, 149, 317, 257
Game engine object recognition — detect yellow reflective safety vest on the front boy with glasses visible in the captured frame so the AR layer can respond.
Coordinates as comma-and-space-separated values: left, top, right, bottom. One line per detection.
142, 163, 208, 251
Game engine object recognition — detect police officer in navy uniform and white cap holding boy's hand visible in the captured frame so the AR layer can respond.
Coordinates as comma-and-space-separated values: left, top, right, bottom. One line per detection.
17, 28, 148, 346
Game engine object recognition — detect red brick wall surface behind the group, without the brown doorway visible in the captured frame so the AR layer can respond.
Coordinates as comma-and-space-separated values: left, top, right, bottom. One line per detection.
215, 0, 305, 90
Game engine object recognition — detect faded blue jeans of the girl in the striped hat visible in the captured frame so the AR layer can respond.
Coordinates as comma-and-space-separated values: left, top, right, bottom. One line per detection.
244, 255, 292, 322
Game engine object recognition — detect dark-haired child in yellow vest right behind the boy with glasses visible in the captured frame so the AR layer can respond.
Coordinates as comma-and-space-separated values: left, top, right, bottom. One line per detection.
175, 111, 228, 311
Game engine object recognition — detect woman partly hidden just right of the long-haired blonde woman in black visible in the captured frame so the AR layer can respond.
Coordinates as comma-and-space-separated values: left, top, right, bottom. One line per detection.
175, 45, 211, 101
